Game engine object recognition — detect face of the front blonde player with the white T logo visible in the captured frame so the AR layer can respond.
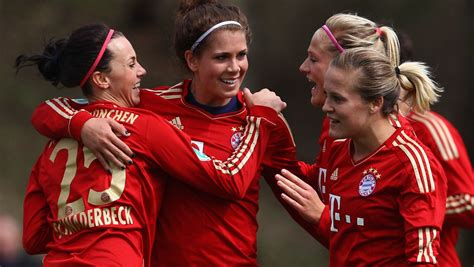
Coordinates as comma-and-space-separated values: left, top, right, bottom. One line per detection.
323, 66, 371, 139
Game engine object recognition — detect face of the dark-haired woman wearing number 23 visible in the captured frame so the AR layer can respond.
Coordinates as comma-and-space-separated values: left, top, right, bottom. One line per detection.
104, 37, 146, 107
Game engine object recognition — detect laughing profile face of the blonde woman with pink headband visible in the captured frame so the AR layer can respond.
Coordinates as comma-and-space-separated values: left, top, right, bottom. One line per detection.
300, 29, 334, 107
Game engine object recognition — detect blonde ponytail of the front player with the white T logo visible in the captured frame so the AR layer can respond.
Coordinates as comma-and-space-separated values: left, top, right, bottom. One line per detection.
399, 61, 443, 113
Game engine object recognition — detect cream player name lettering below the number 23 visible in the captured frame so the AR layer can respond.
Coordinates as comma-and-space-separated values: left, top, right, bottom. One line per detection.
53, 206, 133, 238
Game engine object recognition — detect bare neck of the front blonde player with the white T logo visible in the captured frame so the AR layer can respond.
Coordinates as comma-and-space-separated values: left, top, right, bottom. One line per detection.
352, 116, 396, 161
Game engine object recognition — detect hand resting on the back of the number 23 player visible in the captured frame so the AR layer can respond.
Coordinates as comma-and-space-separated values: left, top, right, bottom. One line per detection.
81, 118, 134, 171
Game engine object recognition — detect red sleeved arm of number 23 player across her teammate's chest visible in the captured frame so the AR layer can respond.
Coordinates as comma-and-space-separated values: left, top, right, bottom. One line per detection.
147, 106, 277, 199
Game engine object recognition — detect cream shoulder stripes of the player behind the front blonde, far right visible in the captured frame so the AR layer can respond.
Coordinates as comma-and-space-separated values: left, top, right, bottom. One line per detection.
412, 113, 459, 161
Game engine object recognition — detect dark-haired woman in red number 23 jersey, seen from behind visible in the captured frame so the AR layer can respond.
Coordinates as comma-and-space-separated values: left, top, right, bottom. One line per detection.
16, 24, 285, 266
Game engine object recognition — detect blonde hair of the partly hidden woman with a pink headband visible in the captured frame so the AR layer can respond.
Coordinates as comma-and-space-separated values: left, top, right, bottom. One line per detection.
319, 13, 400, 67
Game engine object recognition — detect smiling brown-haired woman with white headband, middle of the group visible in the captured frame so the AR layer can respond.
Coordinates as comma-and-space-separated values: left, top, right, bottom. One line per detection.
26, 1, 298, 266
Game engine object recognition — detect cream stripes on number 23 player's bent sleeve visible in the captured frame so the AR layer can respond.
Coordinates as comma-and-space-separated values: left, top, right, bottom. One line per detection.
213, 116, 262, 175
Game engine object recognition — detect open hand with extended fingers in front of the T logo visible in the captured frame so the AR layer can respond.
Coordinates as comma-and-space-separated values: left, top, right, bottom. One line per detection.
275, 169, 324, 224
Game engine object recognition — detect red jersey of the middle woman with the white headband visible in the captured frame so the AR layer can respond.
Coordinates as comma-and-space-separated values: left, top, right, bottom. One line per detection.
32, 80, 299, 266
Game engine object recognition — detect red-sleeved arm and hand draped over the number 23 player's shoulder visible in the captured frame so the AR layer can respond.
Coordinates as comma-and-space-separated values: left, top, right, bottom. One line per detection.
31, 97, 133, 170
